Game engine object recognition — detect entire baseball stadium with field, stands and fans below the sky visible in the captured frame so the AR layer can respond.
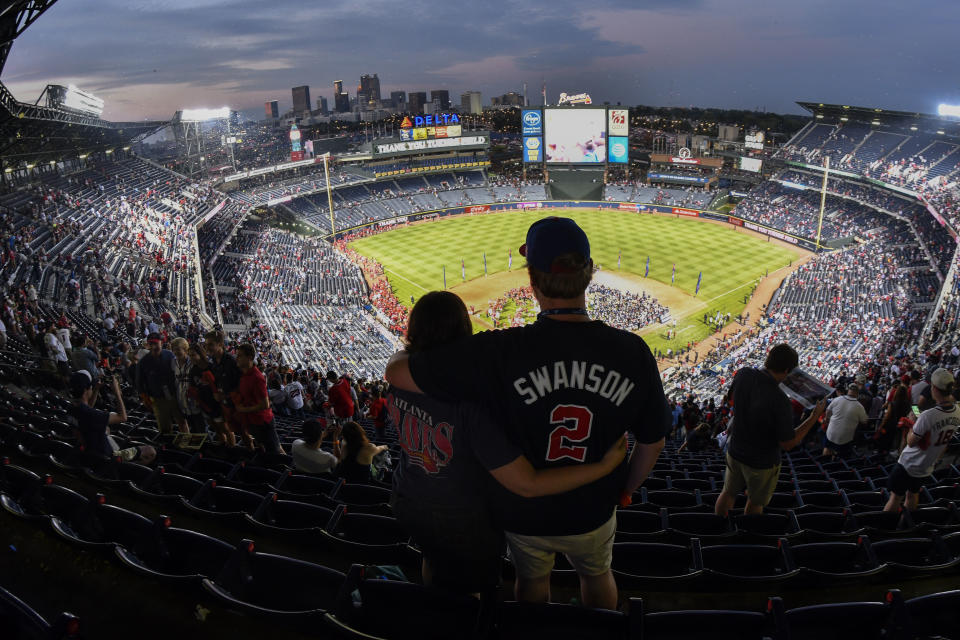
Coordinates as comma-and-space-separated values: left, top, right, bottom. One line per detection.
0, 0, 960, 640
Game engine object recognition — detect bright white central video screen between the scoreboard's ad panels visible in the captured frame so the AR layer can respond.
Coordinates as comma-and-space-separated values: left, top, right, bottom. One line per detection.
543, 109, 607, 164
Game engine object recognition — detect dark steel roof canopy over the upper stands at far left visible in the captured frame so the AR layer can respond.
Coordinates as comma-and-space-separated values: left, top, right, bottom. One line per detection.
0, 0, 167, 167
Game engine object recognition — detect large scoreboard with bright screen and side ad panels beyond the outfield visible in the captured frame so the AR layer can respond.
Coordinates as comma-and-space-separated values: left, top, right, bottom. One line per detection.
520, 107, 630, 165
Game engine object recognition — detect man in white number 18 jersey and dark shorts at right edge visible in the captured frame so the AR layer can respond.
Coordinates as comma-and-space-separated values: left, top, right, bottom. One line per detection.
883, 368, 960, 511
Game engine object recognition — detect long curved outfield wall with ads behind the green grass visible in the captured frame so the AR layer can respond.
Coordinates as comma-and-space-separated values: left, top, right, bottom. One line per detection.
327, 200, 819, 251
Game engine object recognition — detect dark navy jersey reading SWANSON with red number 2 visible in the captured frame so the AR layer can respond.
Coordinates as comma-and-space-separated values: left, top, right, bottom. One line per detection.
410, 318, 671, 536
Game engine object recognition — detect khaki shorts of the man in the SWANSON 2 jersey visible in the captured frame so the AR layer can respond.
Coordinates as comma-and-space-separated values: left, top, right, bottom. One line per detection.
507, 511, 617, 580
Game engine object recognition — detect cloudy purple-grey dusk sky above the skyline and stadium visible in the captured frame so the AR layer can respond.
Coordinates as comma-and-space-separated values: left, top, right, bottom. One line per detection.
2, 0, 960, 120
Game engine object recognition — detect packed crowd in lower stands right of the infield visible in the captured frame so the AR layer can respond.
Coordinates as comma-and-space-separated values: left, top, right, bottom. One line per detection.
668, 221, 930, 412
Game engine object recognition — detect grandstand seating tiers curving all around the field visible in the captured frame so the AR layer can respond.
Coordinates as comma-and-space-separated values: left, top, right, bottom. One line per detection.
0, 1, 960, 639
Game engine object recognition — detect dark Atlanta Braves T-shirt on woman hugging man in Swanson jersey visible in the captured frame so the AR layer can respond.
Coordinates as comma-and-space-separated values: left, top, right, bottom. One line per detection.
387, 389, 522, 507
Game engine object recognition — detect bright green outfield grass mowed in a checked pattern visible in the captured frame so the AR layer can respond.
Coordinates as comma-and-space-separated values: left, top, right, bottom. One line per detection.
352, 209, 800, 350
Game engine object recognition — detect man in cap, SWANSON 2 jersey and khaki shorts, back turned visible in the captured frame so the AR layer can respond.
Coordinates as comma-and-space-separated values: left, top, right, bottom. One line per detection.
386, 218, 671, 609
